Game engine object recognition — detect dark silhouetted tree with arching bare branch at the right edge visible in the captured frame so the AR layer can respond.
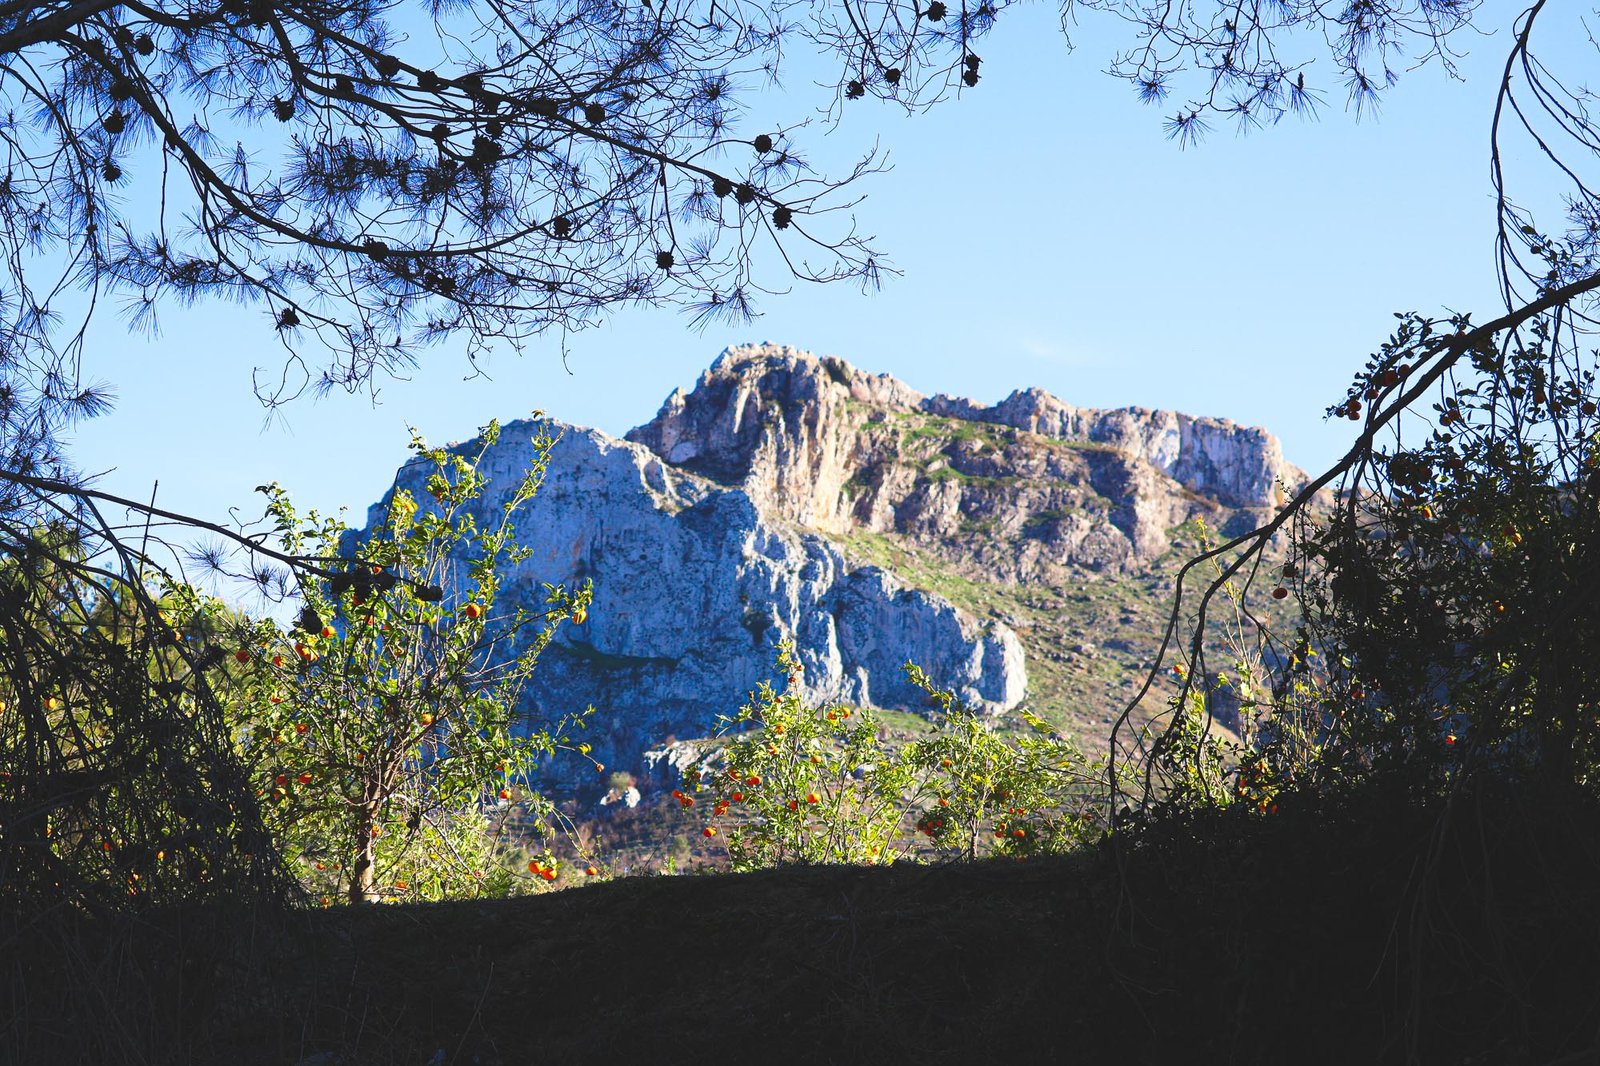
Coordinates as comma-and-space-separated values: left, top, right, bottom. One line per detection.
1114, 2, 1600, 806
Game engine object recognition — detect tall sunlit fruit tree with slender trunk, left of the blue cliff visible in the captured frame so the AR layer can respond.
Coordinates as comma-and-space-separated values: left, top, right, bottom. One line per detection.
217, 423, 592, 903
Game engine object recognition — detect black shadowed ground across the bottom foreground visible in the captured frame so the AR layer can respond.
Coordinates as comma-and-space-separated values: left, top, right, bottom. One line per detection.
12, 771, 1600, 1066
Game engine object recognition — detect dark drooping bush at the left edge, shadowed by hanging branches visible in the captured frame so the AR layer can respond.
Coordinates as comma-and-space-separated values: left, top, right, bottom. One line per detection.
0, 522, 284, 924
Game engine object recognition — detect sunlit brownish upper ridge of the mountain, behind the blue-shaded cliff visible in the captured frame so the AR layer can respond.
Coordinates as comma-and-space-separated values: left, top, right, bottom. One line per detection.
627, 344, 1304, 583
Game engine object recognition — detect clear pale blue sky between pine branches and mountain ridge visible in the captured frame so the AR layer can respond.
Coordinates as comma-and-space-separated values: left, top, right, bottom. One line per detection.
62, 3, 1561, 563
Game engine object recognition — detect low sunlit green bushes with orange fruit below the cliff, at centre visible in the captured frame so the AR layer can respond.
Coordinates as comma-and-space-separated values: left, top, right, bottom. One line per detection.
688, 642, 1104, 869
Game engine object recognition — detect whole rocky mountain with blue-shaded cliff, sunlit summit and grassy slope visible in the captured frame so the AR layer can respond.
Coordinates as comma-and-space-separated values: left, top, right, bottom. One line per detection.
374, 344, 1304, 787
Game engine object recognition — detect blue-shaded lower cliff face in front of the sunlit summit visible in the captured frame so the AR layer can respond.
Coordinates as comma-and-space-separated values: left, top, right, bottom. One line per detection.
370, 423, 1027, 778
